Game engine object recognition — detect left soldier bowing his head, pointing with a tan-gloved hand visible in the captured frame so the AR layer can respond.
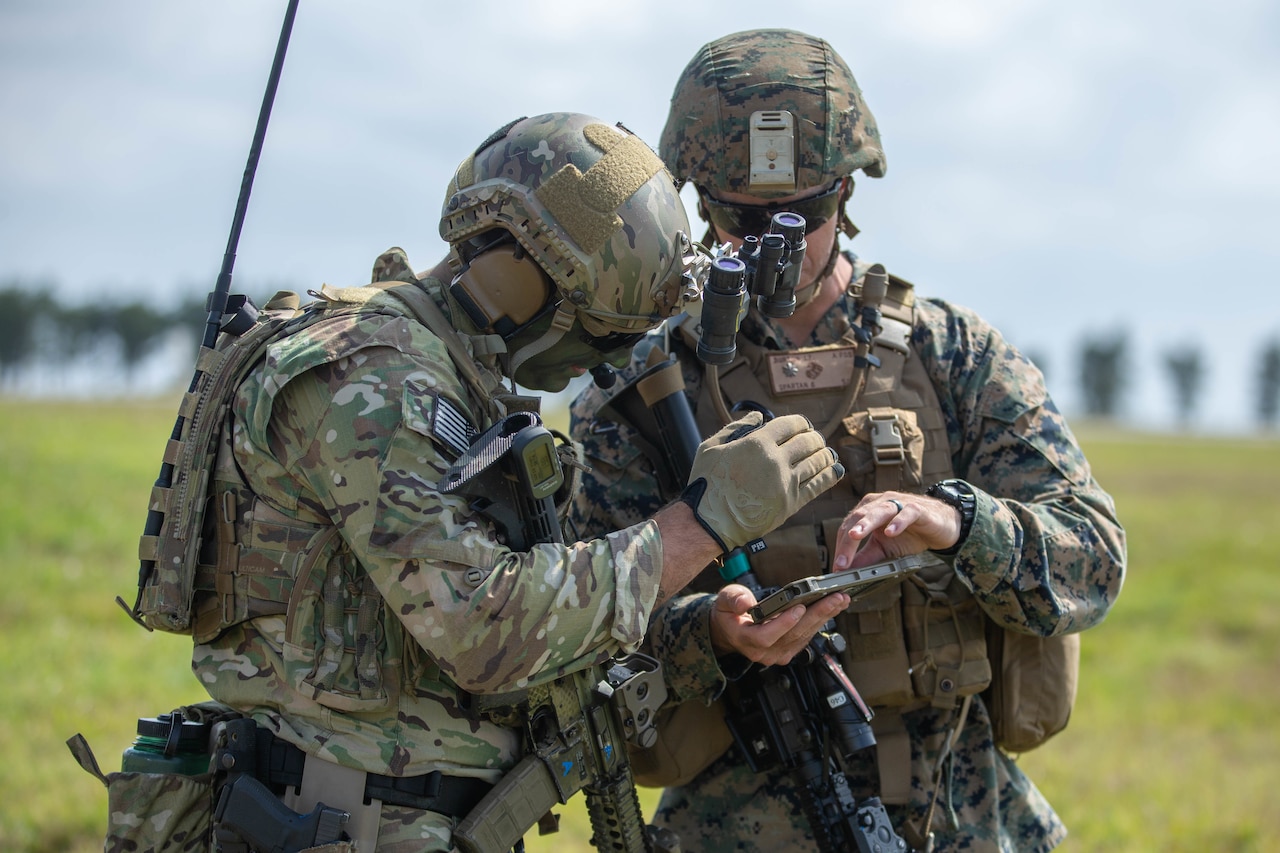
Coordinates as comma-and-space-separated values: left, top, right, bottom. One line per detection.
183, 114, 841, 853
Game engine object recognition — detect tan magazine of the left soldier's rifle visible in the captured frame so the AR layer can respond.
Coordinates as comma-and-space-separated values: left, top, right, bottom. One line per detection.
453, 754, 561, 853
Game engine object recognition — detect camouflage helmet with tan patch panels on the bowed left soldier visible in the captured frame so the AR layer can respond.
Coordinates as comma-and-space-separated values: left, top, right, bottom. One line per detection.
440, 113, 695, 361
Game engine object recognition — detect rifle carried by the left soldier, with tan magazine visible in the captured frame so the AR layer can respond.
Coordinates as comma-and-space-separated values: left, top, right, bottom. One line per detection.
438, 412, 678, 853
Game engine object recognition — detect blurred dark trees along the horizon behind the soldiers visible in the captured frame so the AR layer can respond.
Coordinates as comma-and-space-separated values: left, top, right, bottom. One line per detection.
0, 280, 1280, 430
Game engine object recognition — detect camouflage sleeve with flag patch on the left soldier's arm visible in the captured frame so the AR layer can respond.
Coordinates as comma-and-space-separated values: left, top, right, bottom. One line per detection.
252, 312, 662, 693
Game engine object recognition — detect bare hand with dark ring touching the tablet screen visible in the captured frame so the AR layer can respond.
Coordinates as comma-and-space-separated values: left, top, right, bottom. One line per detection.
832, 492, 960, 571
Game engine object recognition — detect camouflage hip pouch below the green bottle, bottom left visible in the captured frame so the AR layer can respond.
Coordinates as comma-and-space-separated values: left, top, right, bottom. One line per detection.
67, 734, 214, 853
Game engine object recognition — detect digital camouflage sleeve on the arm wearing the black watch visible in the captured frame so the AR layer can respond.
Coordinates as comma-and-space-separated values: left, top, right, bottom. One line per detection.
914, 300, 1125, 635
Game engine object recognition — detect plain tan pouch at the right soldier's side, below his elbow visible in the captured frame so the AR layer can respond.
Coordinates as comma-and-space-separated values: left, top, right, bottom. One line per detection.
983, 620, 1080, 753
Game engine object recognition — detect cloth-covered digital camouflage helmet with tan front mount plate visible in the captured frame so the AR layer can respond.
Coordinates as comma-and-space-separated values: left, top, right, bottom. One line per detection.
659, 29, 886, 199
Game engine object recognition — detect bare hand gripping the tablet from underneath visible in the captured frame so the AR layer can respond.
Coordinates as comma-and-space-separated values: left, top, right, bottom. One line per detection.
712, 584, 849, 666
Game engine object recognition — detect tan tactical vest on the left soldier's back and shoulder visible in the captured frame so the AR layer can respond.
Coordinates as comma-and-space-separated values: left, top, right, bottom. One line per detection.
127, 266, 527, 645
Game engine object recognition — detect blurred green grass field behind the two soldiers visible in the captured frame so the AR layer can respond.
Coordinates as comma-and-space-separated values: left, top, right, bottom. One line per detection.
0, 401, 1280, 853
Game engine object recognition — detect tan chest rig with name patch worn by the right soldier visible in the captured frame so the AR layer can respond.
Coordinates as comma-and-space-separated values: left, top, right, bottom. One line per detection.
680, 264, 991, 803
